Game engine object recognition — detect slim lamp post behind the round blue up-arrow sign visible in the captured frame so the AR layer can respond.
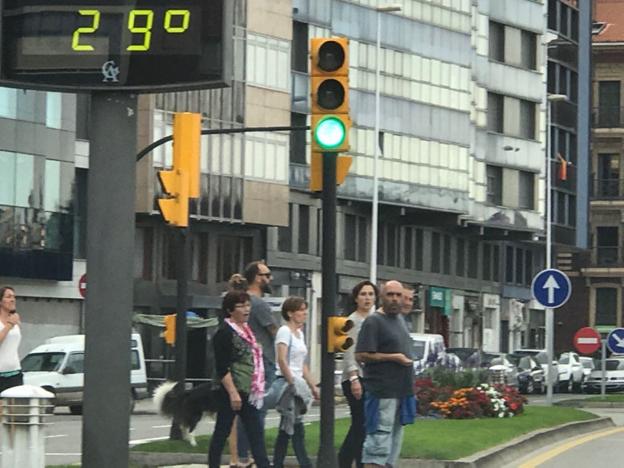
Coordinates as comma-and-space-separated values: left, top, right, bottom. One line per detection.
546, 94, 568, 406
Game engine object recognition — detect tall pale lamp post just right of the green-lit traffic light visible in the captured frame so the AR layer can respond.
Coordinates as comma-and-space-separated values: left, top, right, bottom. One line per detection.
369, 5, 401, 284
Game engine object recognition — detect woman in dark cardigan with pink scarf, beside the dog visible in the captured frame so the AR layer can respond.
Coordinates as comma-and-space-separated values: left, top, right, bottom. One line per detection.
208, 291, 269, 468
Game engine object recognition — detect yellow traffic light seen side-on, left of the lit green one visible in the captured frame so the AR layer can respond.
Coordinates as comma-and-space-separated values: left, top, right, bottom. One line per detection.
158, 112, 201, 227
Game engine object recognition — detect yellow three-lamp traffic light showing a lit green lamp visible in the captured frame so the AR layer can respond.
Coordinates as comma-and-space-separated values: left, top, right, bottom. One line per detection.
310, 37, 351, 153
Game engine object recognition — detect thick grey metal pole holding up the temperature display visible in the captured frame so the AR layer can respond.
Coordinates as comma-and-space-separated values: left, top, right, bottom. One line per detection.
82, 92, 137, 468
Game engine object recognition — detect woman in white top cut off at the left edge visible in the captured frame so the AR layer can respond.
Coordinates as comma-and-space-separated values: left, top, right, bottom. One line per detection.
0, 286, 23, 393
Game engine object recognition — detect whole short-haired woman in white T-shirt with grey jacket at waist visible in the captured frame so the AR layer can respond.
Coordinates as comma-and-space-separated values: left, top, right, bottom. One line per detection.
267, 296, 319, 468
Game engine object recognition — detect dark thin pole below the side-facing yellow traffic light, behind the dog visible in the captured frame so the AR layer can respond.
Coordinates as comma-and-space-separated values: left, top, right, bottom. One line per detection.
169, 228, 190, 440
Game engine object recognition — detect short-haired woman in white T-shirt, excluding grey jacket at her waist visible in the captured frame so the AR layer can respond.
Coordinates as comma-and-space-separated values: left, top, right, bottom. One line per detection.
273, 296, 319, 468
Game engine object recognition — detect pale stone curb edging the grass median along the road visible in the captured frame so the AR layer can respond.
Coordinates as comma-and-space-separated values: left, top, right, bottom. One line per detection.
130, 417, 615, 468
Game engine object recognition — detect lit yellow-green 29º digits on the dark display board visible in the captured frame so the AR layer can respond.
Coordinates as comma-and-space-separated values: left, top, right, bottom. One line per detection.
72, 10, 191, 52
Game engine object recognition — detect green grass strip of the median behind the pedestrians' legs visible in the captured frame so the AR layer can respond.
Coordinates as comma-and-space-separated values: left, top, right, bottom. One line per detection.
132, 406, 597, 460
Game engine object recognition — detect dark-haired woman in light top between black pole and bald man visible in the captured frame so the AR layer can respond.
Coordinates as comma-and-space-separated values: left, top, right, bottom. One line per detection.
338, 281, 379, 468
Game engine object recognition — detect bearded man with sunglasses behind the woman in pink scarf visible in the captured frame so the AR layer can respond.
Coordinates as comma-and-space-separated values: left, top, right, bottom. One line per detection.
236, 260, 278, 466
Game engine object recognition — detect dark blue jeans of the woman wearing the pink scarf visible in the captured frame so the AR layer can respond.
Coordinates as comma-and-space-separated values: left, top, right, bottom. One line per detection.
208, 390, 270, 468
